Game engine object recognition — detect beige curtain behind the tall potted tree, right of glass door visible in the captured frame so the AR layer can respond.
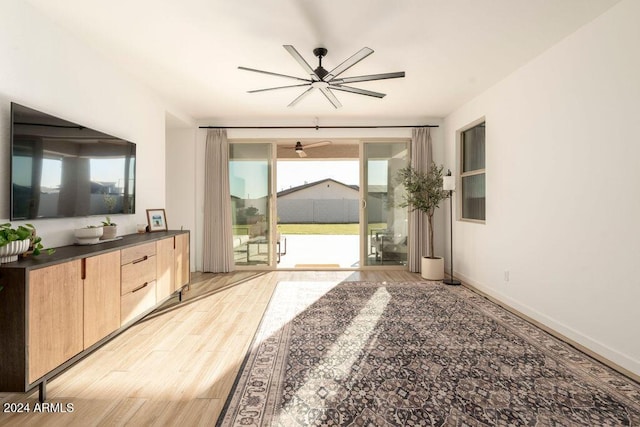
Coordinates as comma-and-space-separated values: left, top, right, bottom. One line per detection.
408, 127, 433, 273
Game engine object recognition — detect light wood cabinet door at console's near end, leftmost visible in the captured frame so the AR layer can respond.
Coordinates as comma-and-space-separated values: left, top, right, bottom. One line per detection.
27, 260, 83, 383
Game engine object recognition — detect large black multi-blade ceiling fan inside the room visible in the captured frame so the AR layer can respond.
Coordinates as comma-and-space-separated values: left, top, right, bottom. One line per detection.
238, 45, 404, 108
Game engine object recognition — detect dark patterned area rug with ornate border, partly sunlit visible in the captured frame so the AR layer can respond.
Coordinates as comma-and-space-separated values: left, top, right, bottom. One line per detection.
218, 282, 640, 426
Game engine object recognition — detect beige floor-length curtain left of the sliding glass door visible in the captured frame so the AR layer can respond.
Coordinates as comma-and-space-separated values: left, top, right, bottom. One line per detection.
202, 129, 234, 273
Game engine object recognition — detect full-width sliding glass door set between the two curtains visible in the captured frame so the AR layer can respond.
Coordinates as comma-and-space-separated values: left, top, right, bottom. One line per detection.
229, 140, 409, 269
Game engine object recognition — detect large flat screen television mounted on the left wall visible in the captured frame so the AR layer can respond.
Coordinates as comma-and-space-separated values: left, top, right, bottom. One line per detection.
10, 103, 136, 220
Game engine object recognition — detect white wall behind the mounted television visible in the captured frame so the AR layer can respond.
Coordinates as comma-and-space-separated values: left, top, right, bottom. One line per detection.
0, 1, 165, 247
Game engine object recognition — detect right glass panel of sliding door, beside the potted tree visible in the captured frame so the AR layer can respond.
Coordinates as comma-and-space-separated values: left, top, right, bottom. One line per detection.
361, 142, 409, 266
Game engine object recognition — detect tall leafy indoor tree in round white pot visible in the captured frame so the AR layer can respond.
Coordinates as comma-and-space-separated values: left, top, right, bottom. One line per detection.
398, 162, 449, 280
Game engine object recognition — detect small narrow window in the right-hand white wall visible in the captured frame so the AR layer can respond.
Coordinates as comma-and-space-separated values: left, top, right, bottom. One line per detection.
460, 122, 485, 222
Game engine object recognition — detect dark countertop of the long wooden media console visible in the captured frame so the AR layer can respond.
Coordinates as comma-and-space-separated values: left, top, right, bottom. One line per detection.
0, 230, 189, 270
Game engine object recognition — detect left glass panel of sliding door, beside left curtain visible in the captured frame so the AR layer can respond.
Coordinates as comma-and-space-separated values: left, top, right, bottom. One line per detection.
229, 143, 274, 267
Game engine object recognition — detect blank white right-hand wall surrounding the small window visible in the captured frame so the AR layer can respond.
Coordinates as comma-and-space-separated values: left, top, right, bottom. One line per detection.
445, 0, 640, 374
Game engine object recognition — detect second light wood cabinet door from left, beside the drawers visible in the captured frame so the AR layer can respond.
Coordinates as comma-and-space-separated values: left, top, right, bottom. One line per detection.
83, 251, 120, 349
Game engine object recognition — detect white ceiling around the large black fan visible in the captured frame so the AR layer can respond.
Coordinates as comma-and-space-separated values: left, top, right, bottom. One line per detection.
28, 0, 619, 124
